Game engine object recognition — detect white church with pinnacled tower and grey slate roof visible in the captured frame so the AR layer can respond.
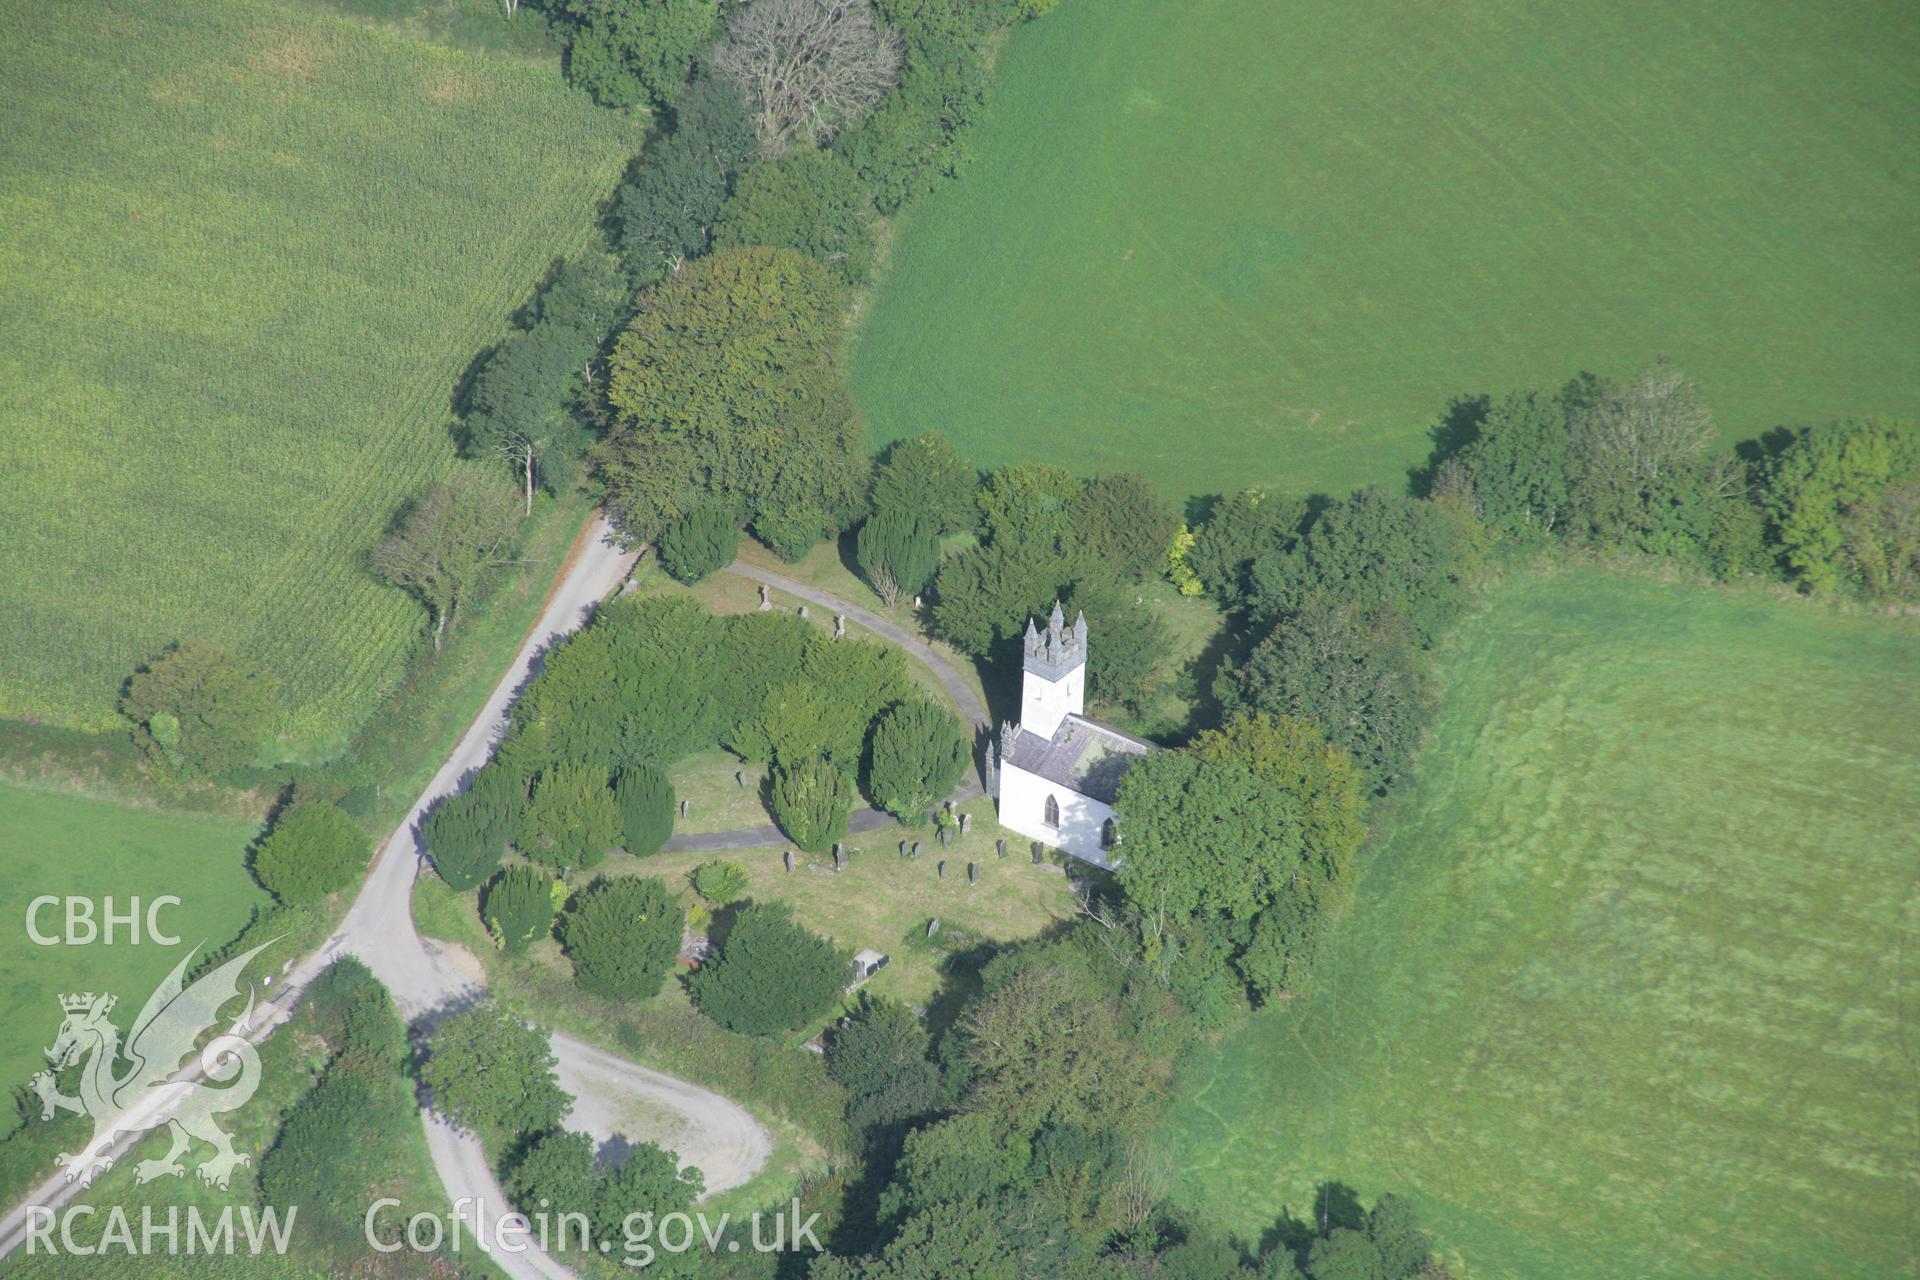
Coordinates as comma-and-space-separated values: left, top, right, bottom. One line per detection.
995, 603, 1152, 867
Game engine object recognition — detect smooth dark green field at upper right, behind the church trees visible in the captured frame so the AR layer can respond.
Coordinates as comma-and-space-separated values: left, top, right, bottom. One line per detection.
854, 0, 1920, 495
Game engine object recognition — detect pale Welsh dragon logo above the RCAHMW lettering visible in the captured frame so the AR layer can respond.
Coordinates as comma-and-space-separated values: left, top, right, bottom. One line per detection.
33, 942, 278, 1190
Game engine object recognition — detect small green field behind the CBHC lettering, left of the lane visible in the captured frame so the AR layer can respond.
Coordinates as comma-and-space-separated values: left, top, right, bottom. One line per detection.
0, 783, 267, 1090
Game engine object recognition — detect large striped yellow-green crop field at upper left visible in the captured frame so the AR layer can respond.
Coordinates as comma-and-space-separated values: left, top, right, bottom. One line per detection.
0, 0, 639, 752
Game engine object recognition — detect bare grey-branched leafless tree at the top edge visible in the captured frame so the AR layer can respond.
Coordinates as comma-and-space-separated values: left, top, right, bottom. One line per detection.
712, 0, 904, 155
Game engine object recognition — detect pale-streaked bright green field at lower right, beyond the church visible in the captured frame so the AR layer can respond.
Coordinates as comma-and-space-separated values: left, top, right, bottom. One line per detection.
1169, 570, 1920, 1280
